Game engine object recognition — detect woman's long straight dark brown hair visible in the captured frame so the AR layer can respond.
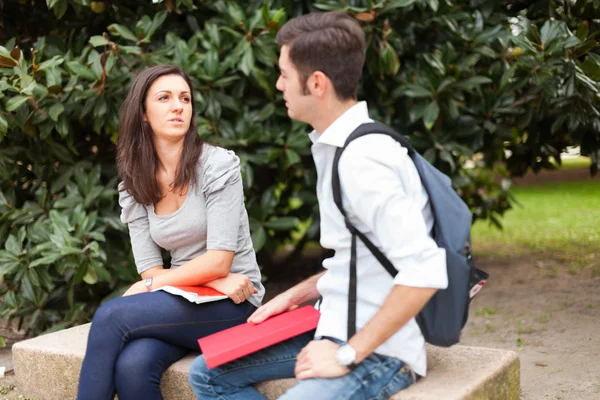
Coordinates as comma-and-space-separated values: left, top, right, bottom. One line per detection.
117, 65, 204, 205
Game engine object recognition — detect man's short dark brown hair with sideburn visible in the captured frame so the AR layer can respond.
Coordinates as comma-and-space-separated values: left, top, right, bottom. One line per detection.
276, 12, 365, 100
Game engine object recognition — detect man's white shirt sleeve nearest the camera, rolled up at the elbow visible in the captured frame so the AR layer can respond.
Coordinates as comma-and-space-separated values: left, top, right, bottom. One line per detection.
339, 135, 448, 289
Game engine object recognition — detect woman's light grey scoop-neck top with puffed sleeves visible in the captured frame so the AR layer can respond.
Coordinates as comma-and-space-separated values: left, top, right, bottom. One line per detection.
119, 144, 265, 307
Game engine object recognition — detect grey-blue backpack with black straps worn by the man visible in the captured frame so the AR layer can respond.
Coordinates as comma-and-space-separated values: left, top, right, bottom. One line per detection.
332, 122, 488, 347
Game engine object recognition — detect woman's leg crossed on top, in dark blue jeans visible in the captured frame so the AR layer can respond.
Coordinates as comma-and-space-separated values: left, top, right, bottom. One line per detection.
77, 292, 255, 400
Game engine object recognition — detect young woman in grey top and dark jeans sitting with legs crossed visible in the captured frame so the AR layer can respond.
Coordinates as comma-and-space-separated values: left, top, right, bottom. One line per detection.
78, 65, 264, 400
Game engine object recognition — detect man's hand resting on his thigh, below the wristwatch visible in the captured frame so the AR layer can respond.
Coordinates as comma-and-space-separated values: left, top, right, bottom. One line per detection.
294, 339, 350, 379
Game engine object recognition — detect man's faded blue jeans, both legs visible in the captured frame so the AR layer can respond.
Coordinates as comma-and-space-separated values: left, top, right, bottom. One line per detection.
189, 331, 414, 400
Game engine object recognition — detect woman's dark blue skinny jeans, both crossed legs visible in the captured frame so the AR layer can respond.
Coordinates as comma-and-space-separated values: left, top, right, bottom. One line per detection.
77, 292, 256, 400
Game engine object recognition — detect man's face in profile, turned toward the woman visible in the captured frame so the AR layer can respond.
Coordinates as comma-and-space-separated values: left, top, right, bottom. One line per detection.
276, 45, 315, 124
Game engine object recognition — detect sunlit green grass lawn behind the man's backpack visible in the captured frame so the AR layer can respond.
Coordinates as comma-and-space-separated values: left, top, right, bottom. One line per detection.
472, 179, 600, 257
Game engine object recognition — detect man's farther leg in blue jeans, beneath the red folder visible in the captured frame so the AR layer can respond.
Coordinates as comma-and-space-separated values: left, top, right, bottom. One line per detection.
189, 331, 314, 400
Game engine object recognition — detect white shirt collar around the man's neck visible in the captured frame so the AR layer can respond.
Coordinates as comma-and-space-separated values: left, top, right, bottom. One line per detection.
308, 101, 370, 147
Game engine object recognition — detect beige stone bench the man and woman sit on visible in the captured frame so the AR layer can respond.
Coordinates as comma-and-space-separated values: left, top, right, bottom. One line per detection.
12, 324, 520, 400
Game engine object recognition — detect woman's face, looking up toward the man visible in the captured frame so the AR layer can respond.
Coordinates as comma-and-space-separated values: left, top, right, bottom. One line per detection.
145, 75, 192, 141
